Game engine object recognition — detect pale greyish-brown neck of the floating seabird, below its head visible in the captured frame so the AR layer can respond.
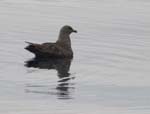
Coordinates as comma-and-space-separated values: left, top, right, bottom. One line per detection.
56, 33, 71, 49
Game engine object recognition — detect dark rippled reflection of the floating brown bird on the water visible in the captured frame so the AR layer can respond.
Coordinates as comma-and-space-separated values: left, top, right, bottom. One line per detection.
25, 58, 74, 99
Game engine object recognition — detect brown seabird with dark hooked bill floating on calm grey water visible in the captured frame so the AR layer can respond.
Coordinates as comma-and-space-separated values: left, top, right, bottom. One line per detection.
25, 25, 77, 58
